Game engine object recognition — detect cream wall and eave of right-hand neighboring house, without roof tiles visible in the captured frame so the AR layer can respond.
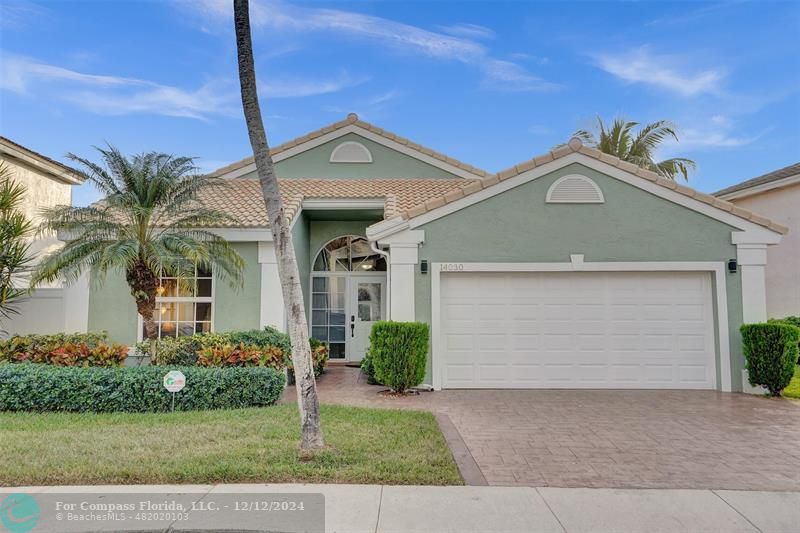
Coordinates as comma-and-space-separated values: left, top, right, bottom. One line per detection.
730, 183, 800, 318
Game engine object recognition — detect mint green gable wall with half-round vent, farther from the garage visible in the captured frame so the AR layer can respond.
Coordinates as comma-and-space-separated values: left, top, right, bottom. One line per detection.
272, 133, 458, 179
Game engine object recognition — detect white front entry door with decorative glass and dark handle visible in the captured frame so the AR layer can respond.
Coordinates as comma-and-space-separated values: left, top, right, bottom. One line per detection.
347, 276, 386, 361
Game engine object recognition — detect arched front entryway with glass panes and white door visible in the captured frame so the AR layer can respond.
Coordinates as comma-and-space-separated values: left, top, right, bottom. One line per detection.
311, 235, 386, 361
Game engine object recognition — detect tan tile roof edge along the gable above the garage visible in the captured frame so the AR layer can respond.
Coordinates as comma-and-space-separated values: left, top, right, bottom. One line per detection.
387, 138, 789, 234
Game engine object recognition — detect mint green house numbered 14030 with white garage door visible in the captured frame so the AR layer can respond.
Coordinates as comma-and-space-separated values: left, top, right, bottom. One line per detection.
78, 115, 786, 391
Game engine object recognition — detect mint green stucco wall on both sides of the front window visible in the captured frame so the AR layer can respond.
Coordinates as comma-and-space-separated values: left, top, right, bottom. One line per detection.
89, 242, 261, 345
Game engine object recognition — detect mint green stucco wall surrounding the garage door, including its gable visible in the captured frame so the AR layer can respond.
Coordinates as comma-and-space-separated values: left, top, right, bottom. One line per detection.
415, 164, 744, 390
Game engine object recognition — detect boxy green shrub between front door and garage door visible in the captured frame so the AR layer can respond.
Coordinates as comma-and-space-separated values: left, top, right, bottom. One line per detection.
369, 321, 430, 392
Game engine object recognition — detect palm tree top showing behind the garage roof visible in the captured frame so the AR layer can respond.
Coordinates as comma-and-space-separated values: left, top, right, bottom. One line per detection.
574, 117, 696, 181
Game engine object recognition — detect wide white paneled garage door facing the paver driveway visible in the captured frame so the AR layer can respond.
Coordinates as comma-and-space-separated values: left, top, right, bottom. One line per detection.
439, 272, 716, 389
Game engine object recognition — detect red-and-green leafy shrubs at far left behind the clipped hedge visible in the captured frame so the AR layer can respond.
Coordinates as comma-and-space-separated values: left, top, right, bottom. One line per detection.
0, 332, 128, 366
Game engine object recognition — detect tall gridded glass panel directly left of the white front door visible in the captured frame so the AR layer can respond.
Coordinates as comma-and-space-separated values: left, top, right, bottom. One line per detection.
311, 276, 347, 359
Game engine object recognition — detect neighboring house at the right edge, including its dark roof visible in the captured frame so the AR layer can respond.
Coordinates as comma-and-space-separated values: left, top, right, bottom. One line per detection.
714, 163, 800, 318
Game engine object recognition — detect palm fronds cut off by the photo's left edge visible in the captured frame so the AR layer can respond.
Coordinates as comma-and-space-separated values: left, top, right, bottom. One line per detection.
0, 164, 34, 319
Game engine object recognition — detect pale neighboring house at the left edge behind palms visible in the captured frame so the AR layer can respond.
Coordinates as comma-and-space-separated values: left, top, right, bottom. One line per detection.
0, 137, 86, 334
